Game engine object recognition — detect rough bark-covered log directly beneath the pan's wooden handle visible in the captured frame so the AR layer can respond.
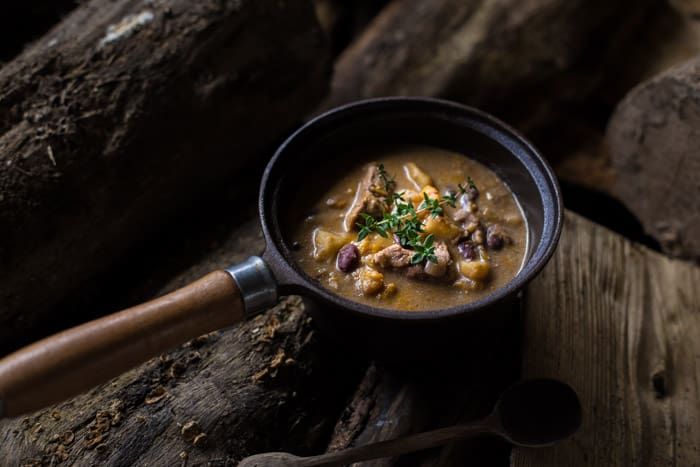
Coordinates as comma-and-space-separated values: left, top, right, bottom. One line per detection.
0, 218, 363, 467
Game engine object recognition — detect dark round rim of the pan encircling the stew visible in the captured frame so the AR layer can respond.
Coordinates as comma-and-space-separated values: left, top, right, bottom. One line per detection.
258, 96, 564, 322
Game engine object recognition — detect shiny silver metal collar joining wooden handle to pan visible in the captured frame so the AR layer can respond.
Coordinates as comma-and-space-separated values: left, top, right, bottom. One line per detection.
226, 256, 277, 318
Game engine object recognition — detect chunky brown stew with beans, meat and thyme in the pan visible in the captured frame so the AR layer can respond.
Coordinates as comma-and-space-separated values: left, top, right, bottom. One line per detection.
290, 146, 527, 311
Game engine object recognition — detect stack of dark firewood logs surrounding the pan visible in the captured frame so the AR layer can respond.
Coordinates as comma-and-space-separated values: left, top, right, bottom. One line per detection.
0, 0, 700, 466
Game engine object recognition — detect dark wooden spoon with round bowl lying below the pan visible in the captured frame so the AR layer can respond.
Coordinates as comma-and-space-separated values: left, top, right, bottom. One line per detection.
238, 379, 581, 467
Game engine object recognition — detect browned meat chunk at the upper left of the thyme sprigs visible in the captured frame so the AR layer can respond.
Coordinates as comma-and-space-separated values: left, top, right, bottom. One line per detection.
344, 164, 394, 232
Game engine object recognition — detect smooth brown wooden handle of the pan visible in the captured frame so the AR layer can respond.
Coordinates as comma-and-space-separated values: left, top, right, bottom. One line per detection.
0, 271, 245, 417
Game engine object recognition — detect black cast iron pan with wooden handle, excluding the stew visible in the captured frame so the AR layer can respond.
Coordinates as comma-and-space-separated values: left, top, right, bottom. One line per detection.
0, 98, 562, 417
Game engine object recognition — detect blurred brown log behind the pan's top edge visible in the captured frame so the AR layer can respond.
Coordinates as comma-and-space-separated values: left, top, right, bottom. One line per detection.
323, 0, 651, 117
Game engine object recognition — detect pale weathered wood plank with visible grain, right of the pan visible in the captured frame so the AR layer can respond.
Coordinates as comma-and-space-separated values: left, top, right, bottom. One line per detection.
512, 213, 700, 467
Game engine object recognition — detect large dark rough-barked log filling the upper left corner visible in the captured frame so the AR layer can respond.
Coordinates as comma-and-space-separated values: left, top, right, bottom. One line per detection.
0, 0, 327, 352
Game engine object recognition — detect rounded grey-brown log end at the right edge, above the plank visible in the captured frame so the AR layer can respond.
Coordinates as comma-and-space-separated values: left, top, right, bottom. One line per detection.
606, 58, 700, 258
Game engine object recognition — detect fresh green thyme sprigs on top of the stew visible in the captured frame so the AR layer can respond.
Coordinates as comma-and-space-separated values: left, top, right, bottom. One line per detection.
355, 164, 476, 264
